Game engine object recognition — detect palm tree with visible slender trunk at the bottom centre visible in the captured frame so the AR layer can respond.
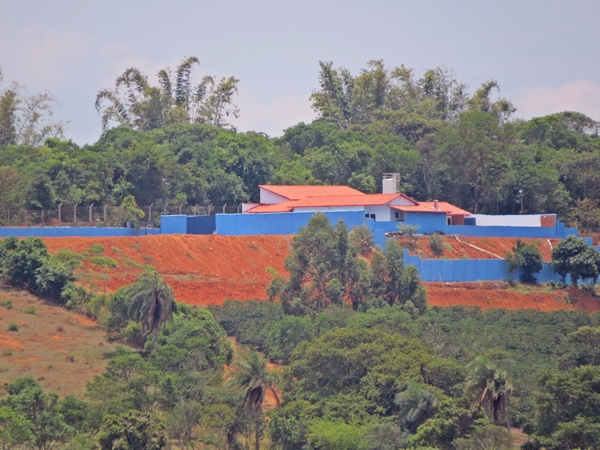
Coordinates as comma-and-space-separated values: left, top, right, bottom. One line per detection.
231, 348, 279, 450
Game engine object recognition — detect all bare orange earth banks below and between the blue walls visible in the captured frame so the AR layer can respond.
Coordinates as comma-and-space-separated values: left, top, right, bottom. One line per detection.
44, 235, 600, 312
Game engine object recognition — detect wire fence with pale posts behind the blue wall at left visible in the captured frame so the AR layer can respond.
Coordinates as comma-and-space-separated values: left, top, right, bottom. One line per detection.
0, 204, 242, 228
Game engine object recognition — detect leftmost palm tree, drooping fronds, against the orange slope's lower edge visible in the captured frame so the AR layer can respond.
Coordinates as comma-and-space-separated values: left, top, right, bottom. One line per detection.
125, 271, 175, 344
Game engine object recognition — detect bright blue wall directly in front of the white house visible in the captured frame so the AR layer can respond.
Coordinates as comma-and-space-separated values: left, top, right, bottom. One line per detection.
216, 211, 366, 236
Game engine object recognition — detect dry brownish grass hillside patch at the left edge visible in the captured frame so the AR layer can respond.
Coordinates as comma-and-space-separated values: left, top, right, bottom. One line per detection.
0, 286, 114, 396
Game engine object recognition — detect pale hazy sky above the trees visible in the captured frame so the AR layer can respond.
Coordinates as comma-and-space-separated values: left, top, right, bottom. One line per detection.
0, 0, 600, 145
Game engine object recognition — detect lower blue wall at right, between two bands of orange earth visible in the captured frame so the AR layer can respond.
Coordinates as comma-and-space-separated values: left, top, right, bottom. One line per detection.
404, 249, 561, 283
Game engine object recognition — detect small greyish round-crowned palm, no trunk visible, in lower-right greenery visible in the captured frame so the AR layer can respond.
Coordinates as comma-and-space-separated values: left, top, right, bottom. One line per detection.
395, 381, 438, 433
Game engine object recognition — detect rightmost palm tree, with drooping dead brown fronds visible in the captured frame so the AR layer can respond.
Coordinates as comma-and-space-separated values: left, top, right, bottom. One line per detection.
465, 355, 512, 425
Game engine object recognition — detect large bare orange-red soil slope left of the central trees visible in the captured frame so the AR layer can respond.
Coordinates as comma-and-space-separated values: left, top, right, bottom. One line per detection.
44, 235, 291, 305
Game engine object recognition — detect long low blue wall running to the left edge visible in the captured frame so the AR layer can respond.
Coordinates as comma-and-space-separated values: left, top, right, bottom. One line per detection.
0, 227, 160, 238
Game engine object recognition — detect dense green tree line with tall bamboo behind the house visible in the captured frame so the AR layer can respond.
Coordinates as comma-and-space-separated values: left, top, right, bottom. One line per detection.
0, 57, 600, 231
